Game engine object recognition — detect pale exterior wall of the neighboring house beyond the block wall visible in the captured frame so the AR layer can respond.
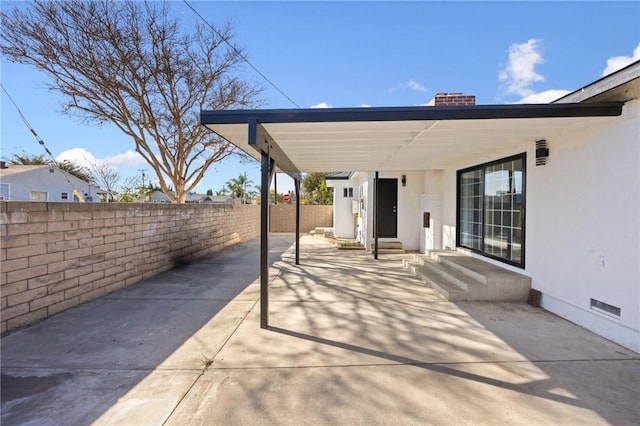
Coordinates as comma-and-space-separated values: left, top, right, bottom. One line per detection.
1, 166, 100, 202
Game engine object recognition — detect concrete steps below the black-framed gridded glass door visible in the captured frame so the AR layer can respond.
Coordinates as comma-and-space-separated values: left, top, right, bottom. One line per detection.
403, 250, 531, 302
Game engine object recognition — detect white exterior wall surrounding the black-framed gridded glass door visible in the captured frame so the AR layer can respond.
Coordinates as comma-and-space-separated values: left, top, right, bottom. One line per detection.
442, 100, 640, 352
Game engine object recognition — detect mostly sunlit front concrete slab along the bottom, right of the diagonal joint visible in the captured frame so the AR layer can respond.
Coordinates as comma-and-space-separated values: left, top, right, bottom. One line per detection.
167, 361, 637, 426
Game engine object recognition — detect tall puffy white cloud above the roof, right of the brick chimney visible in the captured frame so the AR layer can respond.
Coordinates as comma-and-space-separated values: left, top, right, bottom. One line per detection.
498, 38, 544, 96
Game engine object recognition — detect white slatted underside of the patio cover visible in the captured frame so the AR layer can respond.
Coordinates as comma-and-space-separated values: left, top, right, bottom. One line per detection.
207, 117, 615, 173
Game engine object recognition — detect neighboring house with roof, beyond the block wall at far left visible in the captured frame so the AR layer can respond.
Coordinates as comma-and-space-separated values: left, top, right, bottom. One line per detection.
0, 162, 106, 202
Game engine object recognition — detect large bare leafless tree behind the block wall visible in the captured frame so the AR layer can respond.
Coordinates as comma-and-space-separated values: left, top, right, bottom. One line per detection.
0, 0, 260, 203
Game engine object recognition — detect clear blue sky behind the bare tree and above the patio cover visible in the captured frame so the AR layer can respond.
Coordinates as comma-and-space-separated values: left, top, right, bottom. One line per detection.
0, 0, 640, 192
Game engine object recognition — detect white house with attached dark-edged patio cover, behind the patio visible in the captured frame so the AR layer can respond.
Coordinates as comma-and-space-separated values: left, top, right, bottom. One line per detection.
201, 61, 640, 352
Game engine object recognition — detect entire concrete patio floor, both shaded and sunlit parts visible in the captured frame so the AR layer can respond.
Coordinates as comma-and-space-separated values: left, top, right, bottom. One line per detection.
1, 234, 640, 425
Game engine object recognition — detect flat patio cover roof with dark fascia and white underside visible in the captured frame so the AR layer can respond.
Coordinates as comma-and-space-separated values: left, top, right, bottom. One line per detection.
200, 62, 636, 177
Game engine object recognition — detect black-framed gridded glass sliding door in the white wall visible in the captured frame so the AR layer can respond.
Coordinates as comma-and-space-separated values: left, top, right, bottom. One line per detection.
457, 154, 526, 267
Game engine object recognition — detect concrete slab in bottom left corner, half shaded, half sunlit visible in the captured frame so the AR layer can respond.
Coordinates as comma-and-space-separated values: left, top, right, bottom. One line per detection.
2, 368, 202, 426
